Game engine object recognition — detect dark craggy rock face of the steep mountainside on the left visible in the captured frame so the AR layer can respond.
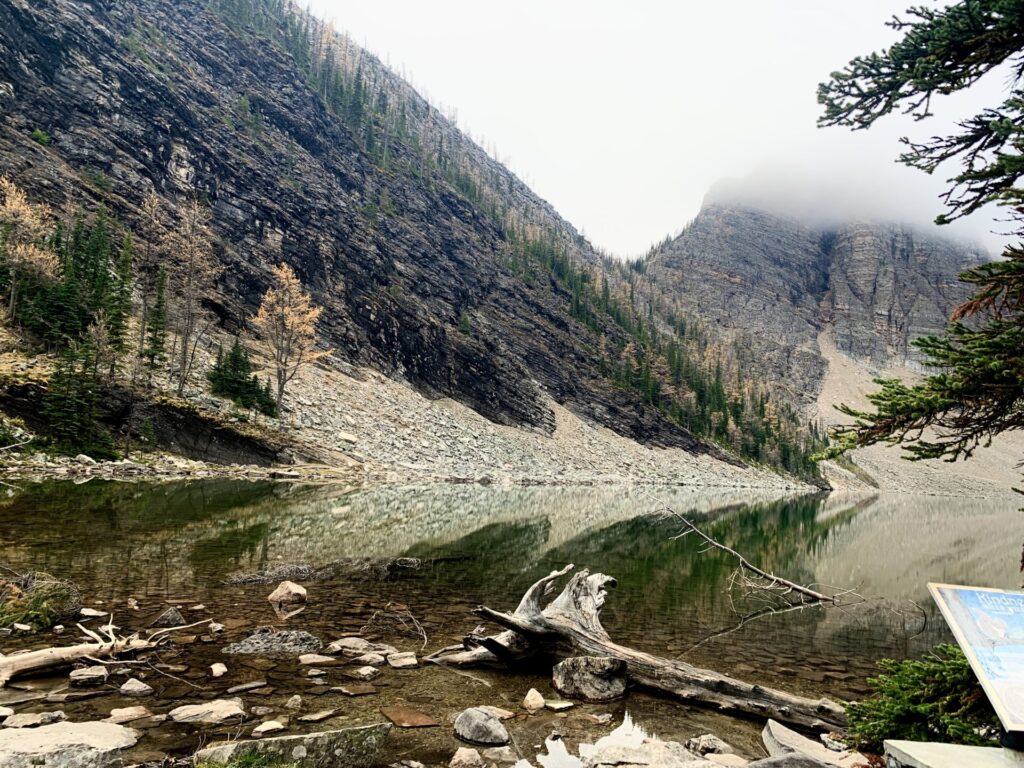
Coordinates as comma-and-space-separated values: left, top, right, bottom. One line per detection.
0, 0, 720, 452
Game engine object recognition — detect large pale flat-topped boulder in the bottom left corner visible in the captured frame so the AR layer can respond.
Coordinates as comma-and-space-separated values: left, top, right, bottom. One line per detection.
0, 723, 138, 768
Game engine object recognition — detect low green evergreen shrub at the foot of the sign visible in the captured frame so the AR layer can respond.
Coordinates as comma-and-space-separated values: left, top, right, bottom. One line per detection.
847, 645, 999, 752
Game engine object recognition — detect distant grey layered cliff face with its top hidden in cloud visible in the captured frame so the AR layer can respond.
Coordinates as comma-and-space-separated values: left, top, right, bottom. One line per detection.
648, 201, 984, 404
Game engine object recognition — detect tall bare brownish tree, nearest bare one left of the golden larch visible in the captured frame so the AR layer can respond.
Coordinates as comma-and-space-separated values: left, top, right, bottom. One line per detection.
167, 201, 221, 396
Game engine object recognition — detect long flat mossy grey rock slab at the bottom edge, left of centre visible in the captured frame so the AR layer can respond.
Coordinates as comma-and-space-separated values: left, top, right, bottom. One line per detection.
196, 723, 391, 768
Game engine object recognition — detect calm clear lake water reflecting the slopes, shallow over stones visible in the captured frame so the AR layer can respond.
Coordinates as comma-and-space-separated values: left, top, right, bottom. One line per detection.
0, 481, 1020, 759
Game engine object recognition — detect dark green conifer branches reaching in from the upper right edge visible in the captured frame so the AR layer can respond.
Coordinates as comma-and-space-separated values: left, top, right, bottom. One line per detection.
818, 0, 1024, 475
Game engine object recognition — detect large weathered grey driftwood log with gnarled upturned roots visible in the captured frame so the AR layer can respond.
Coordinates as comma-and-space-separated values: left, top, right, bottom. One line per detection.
426, 565, 846, 731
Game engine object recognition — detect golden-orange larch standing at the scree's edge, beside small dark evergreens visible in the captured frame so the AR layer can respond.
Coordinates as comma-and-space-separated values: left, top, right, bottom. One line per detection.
253, 264, 330, 424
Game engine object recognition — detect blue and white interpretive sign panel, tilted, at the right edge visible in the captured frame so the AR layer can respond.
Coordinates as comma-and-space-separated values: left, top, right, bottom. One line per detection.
928, 584, 1024, 731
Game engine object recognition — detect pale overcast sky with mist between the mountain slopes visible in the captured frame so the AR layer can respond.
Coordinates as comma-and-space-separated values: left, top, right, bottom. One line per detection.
312, 0, 1005, 256
